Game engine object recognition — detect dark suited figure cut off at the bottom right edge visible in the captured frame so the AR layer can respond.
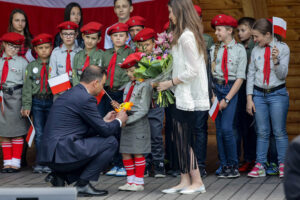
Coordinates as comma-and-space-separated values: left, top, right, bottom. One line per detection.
283, 136, 300, 200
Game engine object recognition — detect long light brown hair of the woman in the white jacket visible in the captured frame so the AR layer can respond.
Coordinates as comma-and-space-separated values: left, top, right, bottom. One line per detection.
168, 0, 207, 60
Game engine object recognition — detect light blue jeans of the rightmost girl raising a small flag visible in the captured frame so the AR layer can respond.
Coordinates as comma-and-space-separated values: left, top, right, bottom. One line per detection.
253, 88, 289, 163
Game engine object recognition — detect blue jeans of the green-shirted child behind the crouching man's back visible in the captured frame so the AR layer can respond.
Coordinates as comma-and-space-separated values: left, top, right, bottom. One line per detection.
31, 98, 53, 157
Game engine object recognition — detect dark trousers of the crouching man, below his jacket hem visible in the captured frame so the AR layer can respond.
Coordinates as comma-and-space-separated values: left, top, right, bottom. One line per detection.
47, 136, 118, 184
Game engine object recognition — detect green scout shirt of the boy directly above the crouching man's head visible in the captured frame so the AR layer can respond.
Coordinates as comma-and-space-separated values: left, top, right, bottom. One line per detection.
72, 47, 104, 86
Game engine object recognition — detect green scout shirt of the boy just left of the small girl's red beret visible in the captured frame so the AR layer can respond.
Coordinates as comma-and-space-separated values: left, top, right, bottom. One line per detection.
102, 46, 134, 90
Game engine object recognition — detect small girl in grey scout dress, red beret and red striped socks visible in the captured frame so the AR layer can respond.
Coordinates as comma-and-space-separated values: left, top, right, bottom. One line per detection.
113, 52, 152, 191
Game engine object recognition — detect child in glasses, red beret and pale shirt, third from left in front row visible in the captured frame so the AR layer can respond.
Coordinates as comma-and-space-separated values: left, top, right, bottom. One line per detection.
49, 21, 82, 80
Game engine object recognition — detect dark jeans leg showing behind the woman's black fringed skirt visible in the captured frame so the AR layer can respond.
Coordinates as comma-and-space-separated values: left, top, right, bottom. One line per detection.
193, 111, 208, 168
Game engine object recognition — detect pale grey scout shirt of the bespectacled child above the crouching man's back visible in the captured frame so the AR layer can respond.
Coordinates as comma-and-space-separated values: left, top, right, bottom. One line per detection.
49, 44, 82, 79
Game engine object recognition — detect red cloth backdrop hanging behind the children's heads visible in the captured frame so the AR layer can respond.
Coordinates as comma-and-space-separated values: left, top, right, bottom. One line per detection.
0, 0, 168, 48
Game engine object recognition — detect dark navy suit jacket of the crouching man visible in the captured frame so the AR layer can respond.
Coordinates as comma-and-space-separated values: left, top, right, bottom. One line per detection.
38, 84, 120, 163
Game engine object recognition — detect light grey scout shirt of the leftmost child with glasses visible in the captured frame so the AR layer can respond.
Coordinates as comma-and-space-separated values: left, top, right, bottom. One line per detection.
0, 53, 28, 88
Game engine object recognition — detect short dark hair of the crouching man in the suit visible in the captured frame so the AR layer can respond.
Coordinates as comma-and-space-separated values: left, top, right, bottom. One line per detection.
80, 65, 107, 83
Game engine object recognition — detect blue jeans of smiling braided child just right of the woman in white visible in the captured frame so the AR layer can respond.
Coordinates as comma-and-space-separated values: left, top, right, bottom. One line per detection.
215, 83, 238, 166
